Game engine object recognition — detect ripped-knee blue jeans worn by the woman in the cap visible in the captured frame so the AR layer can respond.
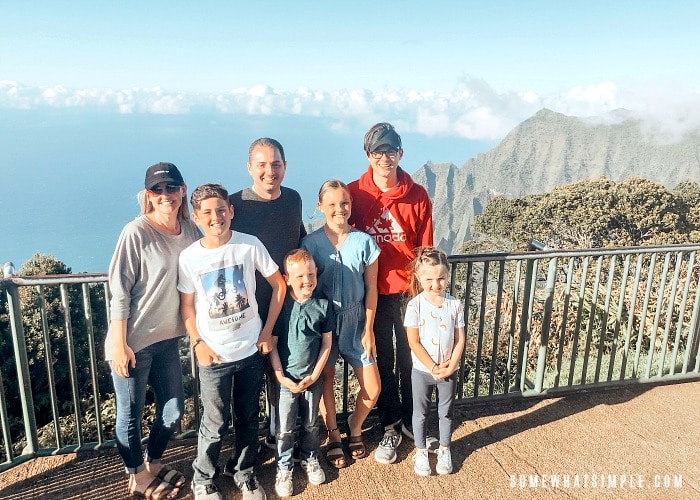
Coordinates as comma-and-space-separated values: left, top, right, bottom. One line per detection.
112, 338, 185, 474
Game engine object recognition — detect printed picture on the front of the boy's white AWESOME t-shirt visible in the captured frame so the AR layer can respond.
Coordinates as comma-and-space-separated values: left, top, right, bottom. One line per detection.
201, 264, 250, 330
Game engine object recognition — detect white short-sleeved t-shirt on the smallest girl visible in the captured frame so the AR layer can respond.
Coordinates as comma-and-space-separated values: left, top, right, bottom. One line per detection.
403, 293, 464, 373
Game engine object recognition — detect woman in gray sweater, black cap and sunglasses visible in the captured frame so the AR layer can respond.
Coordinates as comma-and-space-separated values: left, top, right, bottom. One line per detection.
105, 162, 200, 499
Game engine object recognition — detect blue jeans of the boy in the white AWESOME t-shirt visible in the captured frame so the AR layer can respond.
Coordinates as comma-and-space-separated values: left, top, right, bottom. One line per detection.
192, 352, 264, 484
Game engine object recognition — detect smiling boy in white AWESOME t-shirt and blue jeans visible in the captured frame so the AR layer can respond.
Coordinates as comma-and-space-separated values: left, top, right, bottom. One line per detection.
177, 184, 286, 500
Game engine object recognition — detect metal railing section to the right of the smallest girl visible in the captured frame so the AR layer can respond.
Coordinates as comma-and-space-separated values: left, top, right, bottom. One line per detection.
449, 242, 700, 399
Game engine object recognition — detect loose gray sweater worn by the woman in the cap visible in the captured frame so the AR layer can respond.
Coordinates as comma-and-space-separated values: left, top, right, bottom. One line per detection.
105, 215, 201, 361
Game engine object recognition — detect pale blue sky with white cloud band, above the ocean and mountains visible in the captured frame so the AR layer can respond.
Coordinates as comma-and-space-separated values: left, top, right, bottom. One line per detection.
0, 0, 700, 140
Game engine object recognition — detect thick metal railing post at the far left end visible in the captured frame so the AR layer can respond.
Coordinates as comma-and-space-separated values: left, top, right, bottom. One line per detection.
7, 282, 39, 455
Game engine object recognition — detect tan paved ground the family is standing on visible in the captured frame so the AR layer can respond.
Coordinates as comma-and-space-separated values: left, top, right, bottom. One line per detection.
0, 382, 700, 500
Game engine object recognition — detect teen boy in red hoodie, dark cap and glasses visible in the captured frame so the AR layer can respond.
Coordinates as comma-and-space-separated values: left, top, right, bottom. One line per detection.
348, 123, 433, 464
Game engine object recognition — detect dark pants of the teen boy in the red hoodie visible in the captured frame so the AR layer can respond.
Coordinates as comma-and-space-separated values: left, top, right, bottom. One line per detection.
374, 293, 413, 427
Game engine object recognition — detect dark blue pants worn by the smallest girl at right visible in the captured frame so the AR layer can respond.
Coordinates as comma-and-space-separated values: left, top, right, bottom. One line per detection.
411, 368, 457, 450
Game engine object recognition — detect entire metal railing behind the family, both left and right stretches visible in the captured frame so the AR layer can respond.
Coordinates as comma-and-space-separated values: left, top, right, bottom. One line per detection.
0, 241, 700, 470
